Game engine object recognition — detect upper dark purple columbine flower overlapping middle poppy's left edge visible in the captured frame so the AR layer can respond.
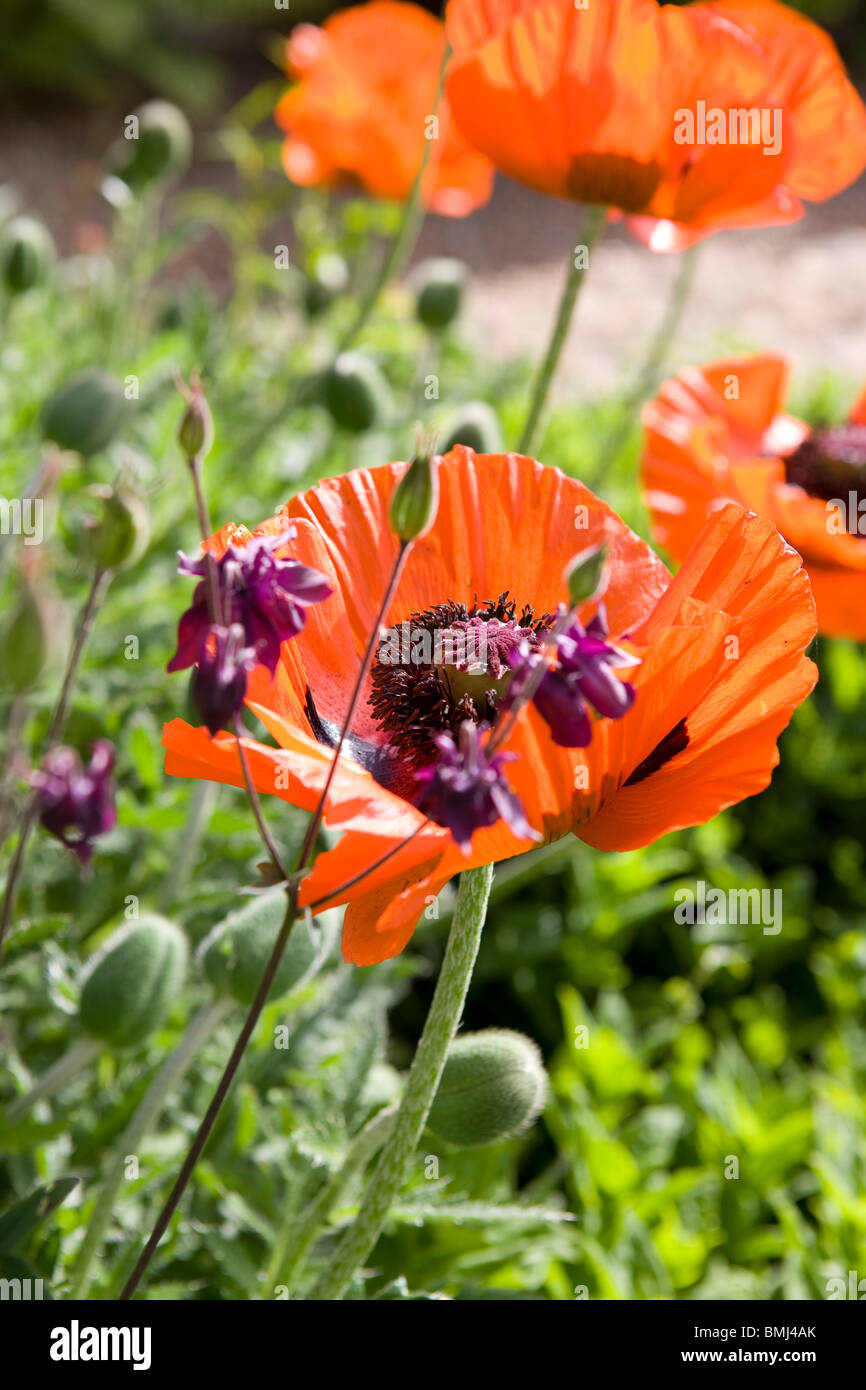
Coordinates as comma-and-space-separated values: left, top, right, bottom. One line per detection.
168, 534, 332, 676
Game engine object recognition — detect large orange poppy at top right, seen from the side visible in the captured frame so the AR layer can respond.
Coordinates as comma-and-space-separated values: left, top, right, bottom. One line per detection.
445, 0, 866, 250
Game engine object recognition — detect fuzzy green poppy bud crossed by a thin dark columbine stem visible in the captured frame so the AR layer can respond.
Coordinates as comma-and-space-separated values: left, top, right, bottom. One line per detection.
199, 890, 316, 1005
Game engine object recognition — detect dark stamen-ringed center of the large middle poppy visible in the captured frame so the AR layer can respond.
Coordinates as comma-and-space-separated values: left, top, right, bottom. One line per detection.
370, 592, 552, 770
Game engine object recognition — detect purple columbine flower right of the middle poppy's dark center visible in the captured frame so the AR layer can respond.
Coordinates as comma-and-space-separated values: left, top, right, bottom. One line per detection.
509, 605, 641, 748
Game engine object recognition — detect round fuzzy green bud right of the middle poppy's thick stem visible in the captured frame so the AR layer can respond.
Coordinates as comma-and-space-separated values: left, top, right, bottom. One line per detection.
427, 1029, 548, 1148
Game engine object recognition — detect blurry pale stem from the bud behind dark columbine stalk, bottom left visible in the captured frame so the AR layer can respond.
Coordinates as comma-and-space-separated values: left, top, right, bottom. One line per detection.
67, 999, 232, 1298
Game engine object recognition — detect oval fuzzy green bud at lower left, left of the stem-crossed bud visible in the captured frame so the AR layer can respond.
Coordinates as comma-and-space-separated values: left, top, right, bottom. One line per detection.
79, 913, 188, 1047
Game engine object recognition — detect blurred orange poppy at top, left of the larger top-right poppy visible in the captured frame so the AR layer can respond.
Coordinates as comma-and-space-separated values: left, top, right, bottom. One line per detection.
274, 0, 493, 217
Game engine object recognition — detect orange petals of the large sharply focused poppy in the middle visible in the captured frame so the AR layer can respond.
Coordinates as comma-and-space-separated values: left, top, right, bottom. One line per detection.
164, 446, 816, 965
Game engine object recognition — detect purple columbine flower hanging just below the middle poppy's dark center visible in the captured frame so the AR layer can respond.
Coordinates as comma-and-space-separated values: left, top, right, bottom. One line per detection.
416, 719, 541, 855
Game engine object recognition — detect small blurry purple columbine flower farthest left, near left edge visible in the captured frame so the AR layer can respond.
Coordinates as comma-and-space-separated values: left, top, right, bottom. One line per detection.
31, 738, 117, 865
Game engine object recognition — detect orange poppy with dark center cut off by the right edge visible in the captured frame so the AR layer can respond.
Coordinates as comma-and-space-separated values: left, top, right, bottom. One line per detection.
641, 354, 866, 641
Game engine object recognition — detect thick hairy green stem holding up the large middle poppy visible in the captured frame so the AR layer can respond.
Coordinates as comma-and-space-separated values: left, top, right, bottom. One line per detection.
310, 865, 493, 1301
